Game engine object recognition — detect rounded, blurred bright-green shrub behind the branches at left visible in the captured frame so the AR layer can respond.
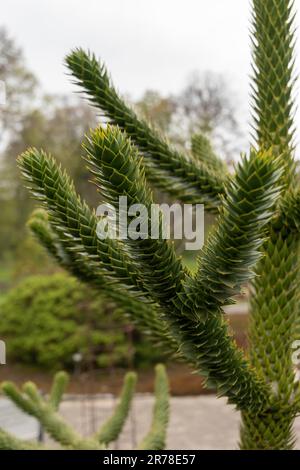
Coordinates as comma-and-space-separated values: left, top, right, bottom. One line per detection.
0, 273, 161, 369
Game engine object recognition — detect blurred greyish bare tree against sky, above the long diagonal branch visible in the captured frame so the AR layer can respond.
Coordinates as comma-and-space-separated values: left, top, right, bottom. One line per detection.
135, 72, 245, 159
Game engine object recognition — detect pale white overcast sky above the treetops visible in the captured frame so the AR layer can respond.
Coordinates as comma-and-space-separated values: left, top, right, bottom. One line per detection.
0, 0, 300, 151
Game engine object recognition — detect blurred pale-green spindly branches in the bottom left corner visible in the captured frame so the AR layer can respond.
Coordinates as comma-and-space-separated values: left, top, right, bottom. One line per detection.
0, 364, 169, 450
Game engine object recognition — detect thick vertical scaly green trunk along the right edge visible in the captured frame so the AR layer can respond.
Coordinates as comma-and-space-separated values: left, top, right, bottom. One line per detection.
241, 0, 300, 450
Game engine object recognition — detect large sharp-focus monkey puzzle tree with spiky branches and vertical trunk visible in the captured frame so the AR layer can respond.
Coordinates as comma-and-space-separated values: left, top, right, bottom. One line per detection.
15, 0, 300, 449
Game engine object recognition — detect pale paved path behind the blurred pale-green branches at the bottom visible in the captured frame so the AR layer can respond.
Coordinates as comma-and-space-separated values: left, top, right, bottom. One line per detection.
0, 395, 300, 449
